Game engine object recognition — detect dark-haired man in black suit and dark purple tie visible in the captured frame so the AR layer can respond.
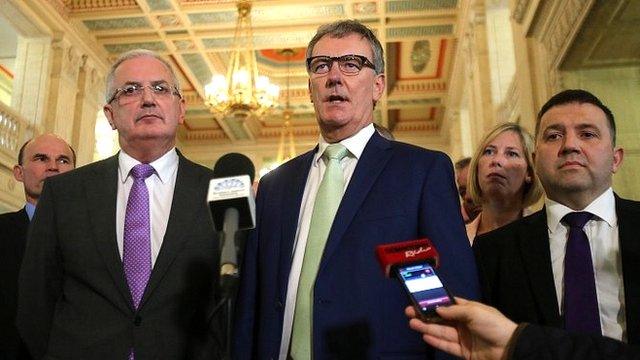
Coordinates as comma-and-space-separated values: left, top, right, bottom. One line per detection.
474, 90, 640, 344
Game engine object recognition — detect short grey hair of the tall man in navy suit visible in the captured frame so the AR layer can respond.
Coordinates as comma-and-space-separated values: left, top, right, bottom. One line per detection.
306, 20, 384, 75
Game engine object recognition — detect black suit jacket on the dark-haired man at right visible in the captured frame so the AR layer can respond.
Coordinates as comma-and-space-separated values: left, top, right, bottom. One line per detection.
473, 196, 640, 344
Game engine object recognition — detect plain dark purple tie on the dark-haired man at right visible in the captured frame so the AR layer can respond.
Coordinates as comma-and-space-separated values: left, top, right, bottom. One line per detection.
562, 211, 601, 335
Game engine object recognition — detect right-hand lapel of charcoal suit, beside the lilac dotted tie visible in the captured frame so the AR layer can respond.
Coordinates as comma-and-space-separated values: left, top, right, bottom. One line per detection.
140, 153, 205, 307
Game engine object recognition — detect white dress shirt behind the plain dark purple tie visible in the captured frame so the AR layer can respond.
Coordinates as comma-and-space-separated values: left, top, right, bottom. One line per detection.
545, 188, 626, 341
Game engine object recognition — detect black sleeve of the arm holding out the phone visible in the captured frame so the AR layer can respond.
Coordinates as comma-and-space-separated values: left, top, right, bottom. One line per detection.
509, 324, 640, 360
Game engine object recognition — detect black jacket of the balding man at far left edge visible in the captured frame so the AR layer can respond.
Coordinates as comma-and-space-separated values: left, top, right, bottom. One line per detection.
0, 208, 29, 360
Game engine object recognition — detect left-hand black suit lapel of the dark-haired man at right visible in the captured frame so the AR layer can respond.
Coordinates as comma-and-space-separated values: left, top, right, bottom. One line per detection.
518, 208, 563, 327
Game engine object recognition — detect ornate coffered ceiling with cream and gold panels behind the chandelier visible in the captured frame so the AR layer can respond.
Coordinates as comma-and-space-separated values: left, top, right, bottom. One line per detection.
52, 0, 458, 144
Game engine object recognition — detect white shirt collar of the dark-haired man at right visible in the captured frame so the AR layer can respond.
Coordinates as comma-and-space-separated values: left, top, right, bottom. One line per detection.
544, 188, 618, 232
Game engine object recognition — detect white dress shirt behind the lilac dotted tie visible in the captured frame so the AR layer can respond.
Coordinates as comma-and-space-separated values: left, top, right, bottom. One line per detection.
116, 148, 178, 268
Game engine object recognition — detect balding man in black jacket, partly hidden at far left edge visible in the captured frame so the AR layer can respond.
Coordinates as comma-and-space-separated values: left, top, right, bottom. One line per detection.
0, 134, 76, 360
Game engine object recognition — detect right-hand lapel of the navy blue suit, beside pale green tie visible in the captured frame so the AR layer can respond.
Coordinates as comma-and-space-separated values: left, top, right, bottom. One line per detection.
318, 132, 392, 271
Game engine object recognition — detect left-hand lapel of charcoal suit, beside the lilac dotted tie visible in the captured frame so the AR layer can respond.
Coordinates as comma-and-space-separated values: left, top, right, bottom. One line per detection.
86, 155, 132, 310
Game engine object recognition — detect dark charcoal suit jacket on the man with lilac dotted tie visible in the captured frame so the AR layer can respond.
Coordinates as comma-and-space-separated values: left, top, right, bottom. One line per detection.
17, 156, 219, 360
